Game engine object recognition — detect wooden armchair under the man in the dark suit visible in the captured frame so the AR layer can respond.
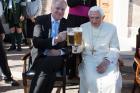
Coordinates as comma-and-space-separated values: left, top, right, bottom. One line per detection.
22, 53, 66, 93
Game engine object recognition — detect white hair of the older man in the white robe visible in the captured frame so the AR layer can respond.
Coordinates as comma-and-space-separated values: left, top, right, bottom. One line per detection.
88, 6, 105, 17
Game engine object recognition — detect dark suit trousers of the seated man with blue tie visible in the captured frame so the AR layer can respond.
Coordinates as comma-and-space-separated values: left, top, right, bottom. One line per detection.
29, 56, 64, 93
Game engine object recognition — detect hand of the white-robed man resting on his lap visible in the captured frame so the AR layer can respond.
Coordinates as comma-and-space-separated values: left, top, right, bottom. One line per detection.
96, 59, 110, 74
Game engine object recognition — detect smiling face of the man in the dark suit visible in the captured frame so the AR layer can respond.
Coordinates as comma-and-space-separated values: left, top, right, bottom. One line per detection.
51, 2, 66, 20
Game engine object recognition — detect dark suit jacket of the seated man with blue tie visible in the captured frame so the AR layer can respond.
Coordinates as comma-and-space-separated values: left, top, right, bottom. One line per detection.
33, 14, 69, 68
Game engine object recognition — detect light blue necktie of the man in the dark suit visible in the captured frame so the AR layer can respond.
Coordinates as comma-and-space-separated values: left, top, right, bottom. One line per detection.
51, 21, 59, 37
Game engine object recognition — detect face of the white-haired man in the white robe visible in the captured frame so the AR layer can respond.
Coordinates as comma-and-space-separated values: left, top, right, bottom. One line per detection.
89, 11, 104, 28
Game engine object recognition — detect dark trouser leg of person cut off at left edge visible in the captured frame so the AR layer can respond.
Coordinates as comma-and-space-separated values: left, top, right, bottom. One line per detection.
0, 40, 11, 79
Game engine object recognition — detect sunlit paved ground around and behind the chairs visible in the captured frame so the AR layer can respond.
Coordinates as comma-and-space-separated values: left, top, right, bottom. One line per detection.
0, 44, 140, 93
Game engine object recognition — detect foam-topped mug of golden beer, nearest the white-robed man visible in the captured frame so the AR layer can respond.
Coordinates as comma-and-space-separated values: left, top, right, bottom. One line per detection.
73, 27, 82, 46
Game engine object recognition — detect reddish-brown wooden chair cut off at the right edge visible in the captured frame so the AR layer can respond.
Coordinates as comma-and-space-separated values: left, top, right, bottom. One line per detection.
132, 28, 140, 93
